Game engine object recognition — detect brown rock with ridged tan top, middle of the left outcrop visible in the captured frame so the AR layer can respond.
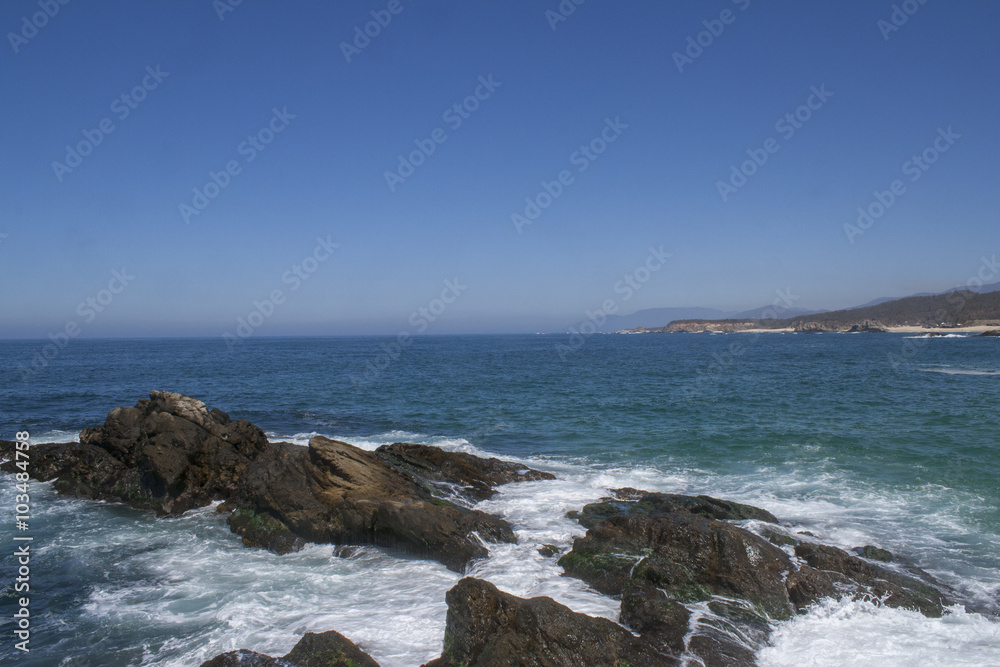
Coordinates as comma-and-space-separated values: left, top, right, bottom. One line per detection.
230, 436, 517, 572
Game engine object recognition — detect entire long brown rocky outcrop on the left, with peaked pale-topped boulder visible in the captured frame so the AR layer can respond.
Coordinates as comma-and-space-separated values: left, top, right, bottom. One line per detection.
3, 391, 551, 572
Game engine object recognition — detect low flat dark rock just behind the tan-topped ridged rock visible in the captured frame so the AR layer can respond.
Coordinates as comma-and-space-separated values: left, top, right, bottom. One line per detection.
376, 442, 555, 501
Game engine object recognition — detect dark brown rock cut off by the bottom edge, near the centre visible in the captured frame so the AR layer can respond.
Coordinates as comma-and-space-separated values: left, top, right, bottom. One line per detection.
425, 578, 678, 667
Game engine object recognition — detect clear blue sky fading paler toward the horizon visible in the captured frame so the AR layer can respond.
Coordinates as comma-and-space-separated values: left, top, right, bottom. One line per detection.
0, 0, 1000, 339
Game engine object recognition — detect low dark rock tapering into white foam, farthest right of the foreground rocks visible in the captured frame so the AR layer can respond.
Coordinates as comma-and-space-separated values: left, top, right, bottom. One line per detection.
790, 542, 951, 618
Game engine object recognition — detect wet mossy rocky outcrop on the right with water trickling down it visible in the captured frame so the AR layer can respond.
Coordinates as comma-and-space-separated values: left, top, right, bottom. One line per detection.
559, 489, 948, 665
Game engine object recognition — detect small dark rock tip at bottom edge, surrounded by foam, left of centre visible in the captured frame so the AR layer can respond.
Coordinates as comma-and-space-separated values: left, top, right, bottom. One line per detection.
201, 630, 379, 667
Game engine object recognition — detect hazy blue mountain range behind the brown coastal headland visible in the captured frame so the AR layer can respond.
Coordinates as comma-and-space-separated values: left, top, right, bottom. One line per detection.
574, 282, 1000, 333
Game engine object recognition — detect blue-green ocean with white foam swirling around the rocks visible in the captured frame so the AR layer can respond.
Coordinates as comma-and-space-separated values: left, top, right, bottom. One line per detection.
0, 333, 1000, 667
